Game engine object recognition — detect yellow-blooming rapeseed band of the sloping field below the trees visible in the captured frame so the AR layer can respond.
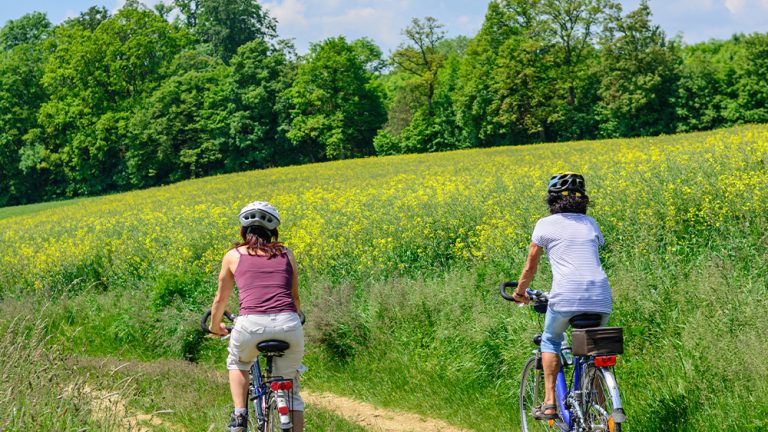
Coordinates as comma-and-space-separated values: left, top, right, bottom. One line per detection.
0, 126, 768, 293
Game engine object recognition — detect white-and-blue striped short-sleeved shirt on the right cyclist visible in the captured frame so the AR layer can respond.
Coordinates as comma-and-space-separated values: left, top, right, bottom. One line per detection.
532, 213, 613, 313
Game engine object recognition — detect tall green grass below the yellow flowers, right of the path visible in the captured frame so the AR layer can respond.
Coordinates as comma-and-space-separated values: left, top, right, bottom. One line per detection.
298, 256, 768, 431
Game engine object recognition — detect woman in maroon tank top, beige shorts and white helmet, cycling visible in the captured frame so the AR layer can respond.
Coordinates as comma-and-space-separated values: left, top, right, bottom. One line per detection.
210, 201, 304, 432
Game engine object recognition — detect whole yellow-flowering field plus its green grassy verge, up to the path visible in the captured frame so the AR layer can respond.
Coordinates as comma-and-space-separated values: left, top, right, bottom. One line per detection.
0, 126, 768, 431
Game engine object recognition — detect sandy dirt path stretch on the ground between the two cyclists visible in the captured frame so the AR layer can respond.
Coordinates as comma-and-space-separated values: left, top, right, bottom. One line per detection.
301, 390, 468, 432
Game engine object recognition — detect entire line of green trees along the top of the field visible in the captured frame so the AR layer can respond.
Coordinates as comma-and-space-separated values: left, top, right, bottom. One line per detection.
0, 0, 768, 205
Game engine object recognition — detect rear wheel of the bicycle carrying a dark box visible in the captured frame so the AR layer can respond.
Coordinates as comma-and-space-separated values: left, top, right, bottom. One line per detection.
584, 368, 621, 432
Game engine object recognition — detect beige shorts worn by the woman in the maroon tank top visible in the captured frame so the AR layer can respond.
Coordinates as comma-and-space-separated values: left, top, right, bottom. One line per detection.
227, 312, 304, 411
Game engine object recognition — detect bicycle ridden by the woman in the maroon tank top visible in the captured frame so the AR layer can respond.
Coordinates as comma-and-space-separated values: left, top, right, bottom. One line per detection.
200, 309, 304, 432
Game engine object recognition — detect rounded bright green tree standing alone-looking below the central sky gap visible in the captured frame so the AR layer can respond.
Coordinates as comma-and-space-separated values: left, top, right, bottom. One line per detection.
286, 37, 386, 161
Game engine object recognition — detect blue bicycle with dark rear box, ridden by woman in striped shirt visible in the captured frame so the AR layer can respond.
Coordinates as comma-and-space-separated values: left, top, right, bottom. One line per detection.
500, 282, 627, 432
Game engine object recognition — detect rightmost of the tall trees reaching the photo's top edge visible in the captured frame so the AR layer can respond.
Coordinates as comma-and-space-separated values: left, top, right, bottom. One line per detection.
597, 1, 680, 137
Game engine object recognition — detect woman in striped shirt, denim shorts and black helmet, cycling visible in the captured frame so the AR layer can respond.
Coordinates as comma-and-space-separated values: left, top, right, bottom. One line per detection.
514, 173, 613, 420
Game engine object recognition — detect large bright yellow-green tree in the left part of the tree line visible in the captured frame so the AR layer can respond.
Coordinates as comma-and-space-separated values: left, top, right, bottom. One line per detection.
24, 7, 183, 196
